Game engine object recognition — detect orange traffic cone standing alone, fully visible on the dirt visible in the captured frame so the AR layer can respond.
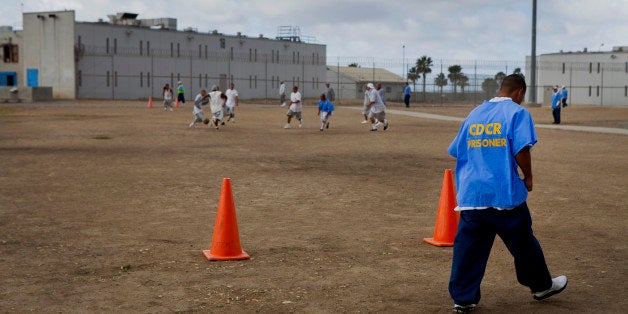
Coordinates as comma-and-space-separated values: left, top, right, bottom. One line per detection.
203, 178, 251, 261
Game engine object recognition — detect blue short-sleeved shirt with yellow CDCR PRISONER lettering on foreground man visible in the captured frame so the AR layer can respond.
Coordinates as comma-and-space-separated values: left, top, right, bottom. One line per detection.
448, 97, 537, 209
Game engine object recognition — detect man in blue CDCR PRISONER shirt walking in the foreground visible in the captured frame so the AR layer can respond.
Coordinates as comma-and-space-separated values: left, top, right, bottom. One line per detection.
448, 74, 567, 313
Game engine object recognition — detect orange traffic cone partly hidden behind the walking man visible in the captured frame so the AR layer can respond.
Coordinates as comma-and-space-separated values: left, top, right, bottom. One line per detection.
423, 169, 460, 246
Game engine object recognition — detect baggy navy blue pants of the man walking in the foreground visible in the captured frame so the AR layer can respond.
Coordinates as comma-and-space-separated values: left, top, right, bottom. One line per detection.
449, 202, 552, 305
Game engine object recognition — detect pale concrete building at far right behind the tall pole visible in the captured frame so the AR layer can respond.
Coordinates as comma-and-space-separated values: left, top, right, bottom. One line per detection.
526, 46, 628, 106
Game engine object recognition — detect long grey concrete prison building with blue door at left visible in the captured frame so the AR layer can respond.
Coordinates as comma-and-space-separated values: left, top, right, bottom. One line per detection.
6, 11, 326, 99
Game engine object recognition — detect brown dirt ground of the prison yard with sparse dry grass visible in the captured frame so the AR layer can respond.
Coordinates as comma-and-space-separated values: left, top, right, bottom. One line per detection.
0, 101, 628, 313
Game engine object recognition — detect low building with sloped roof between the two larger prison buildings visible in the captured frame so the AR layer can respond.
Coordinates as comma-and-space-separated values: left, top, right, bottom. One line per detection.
327, 66, 406, 101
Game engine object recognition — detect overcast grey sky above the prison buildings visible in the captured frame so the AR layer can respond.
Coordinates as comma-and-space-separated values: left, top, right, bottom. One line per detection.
0, 0, 628, 64
